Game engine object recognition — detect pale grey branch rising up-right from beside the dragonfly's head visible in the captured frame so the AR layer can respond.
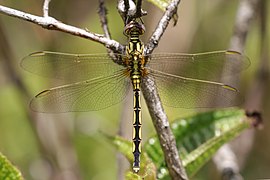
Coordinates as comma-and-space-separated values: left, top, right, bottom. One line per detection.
144, 0, 181, 55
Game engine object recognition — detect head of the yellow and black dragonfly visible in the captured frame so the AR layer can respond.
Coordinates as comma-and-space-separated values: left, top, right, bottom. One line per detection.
124, 20, 145, 36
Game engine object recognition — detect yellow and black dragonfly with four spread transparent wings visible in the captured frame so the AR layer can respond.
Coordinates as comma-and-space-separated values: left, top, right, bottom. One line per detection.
21, 21, 250, 172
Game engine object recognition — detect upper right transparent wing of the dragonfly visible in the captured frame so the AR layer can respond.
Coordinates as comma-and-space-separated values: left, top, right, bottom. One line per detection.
148, 51, 250, 82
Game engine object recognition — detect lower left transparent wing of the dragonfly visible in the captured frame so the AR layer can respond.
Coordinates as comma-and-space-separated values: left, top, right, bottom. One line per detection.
30, 71, 130, 113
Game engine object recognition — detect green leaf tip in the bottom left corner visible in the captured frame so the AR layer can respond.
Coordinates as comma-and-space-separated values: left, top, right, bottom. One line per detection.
0, 153, 23, 180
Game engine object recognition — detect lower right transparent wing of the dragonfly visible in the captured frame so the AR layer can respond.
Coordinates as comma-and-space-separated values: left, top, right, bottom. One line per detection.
149, 70, 242, 108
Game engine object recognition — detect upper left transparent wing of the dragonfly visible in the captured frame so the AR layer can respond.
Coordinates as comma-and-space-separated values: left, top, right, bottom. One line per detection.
21, 51, 124, 82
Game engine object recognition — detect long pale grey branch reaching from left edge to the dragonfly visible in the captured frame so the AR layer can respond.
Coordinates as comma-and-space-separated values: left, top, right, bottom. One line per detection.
0, 5, 124, 53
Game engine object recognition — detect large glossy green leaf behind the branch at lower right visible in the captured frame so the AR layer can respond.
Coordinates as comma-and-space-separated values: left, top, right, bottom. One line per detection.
144, 109, 250, 179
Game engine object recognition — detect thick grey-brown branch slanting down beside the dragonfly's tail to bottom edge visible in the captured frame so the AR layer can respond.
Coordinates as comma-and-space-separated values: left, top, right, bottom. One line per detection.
142, 76, 188, 180
